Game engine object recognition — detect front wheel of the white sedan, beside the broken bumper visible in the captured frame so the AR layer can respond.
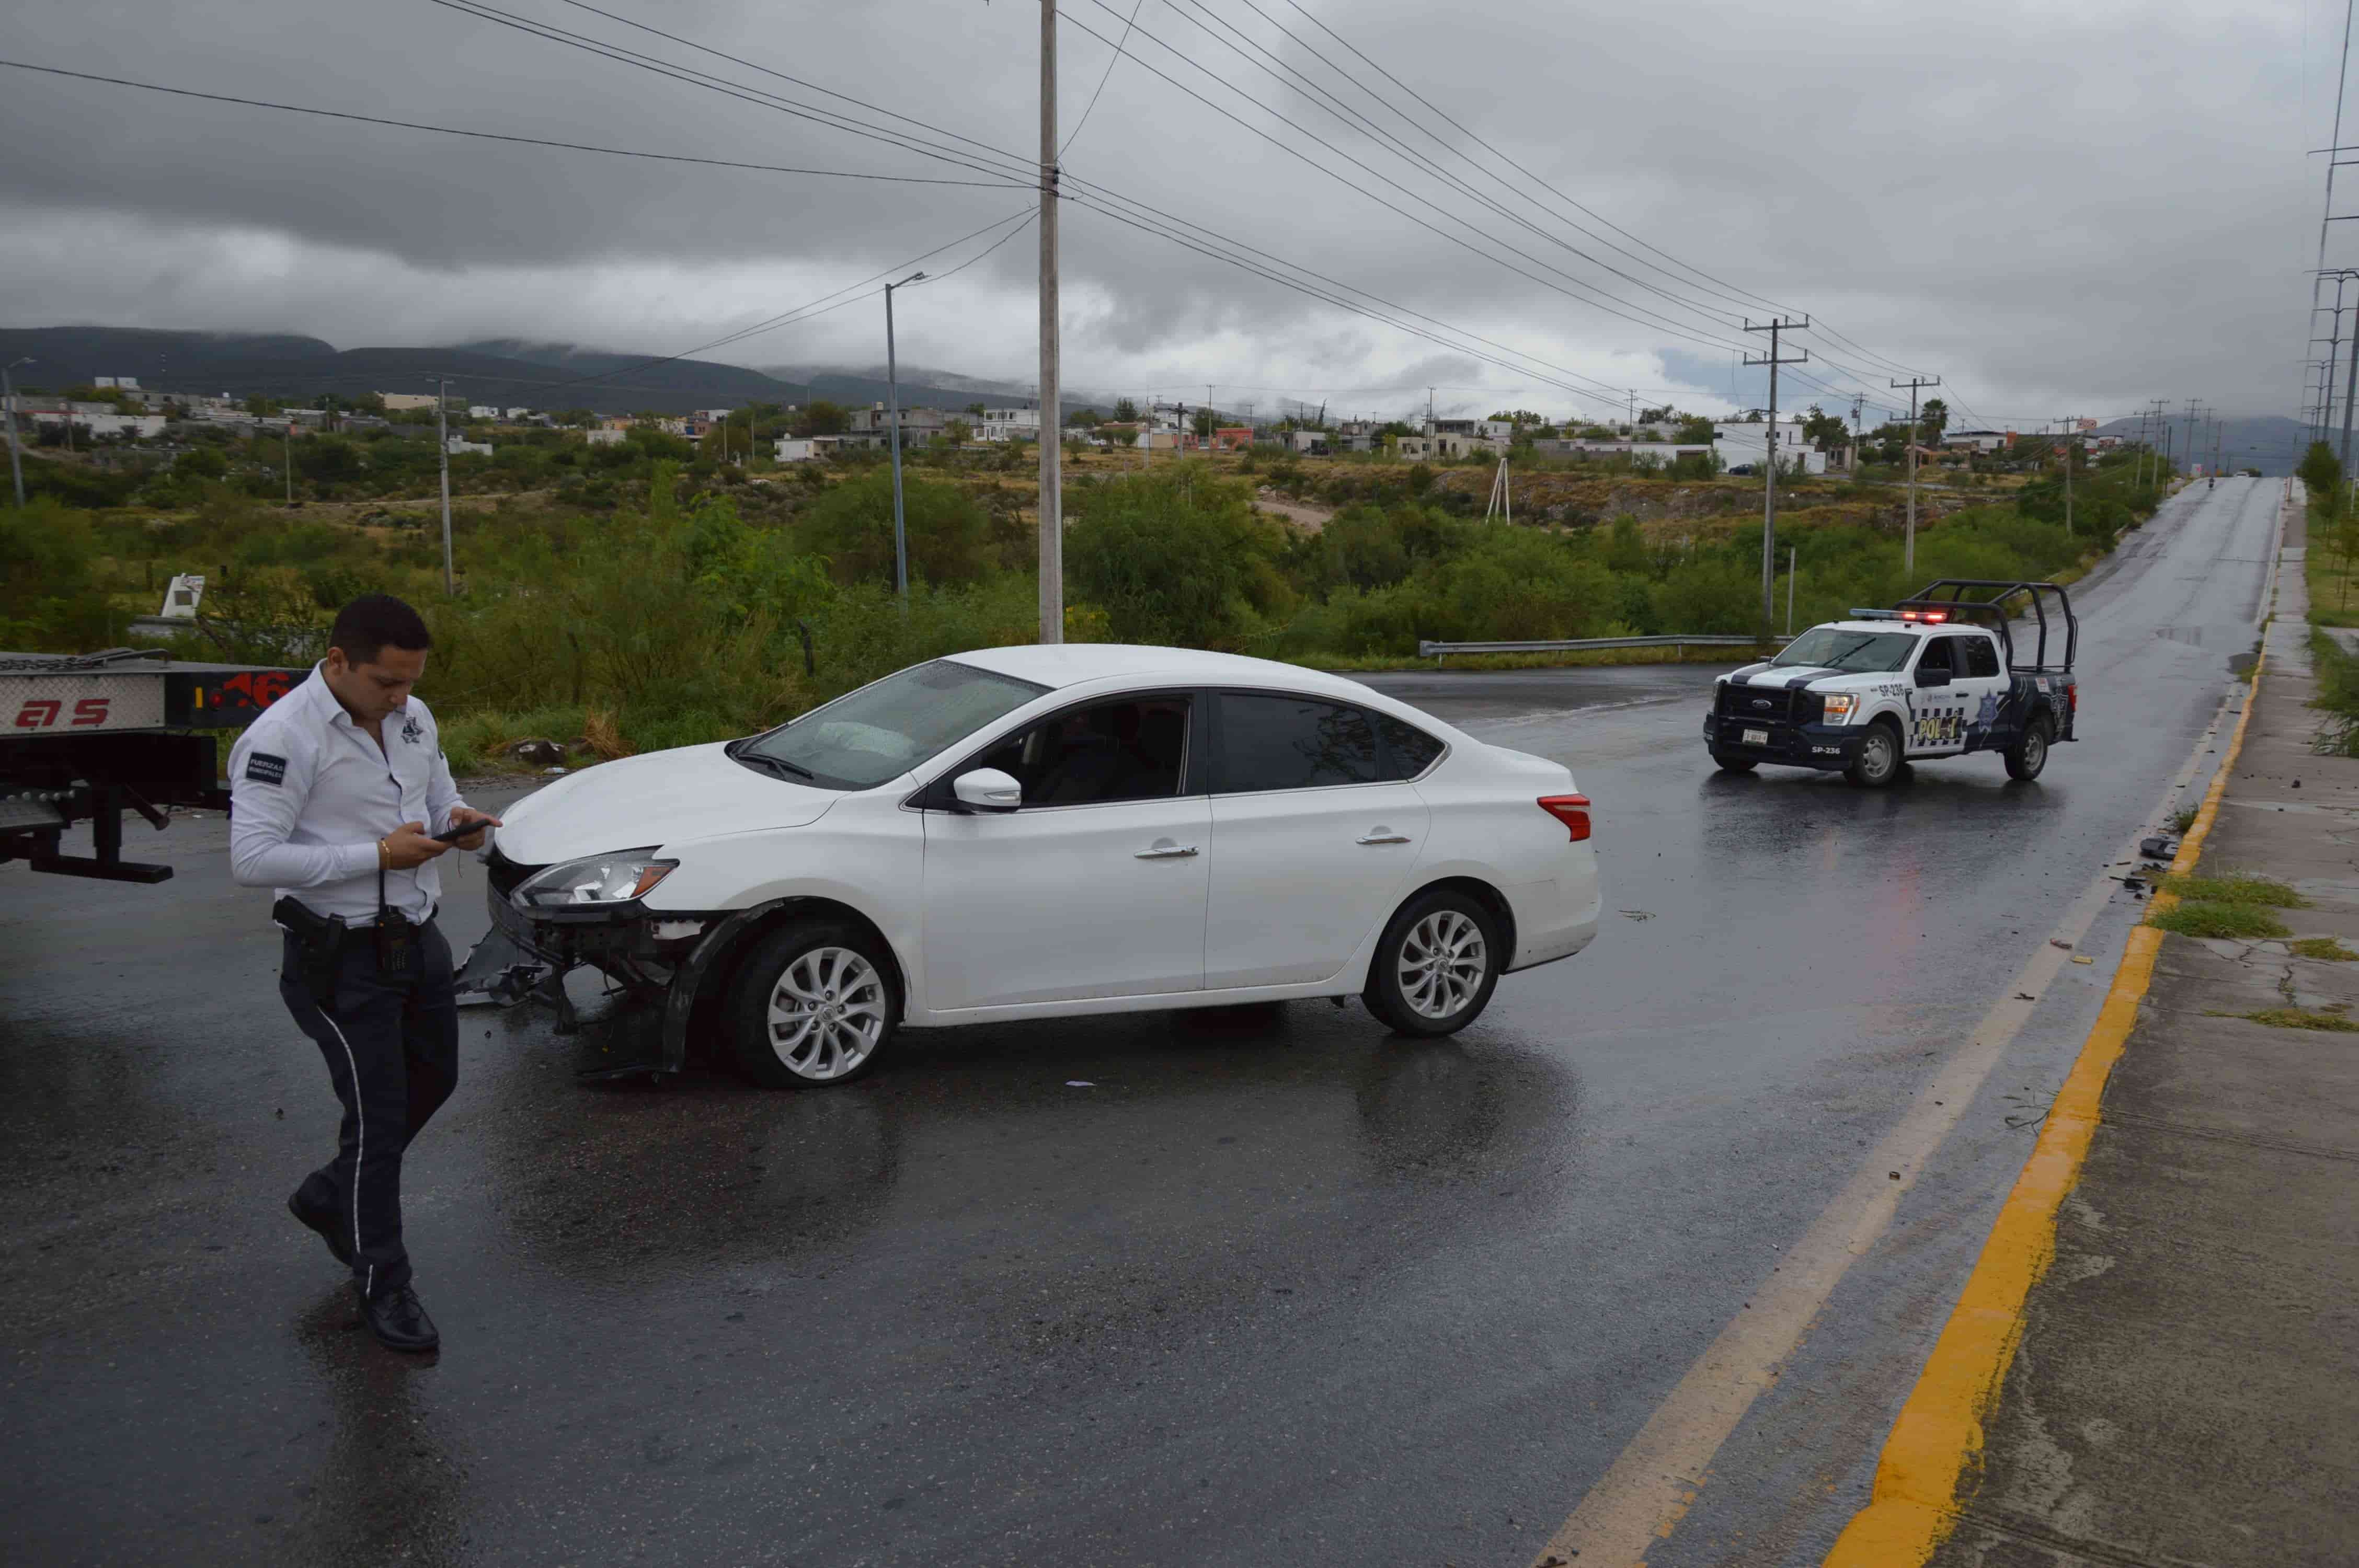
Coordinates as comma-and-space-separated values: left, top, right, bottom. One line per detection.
724, 919, 901, 1089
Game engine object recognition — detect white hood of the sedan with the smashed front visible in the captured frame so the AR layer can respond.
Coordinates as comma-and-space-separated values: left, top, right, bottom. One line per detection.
493, 745, 842, 866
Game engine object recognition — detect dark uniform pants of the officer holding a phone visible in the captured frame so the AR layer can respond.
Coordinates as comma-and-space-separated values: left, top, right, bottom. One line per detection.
278, 922, 457, 1295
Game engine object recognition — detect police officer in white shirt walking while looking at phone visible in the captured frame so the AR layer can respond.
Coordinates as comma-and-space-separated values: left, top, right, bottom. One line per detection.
229, 594, 500, 1351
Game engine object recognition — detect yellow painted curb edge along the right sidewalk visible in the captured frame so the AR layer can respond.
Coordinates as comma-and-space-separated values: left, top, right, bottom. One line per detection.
1826, 665, 2260, 1568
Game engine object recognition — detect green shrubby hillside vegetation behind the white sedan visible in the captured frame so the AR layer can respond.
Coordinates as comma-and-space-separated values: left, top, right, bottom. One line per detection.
0, 434, 2158, 771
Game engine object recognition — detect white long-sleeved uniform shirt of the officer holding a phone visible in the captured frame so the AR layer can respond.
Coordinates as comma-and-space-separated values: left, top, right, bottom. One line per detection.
229, 665, 467, 924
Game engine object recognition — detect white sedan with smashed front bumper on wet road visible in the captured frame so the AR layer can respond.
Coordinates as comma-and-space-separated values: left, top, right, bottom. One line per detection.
486, 644, 1599, 1087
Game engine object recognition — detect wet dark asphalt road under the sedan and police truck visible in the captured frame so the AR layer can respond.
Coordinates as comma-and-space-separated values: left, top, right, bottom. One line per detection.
0, 481, 2279, 1568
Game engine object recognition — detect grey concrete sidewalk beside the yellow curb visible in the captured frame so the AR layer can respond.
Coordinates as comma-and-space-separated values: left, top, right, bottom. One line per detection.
1932, 490, 2359, 1568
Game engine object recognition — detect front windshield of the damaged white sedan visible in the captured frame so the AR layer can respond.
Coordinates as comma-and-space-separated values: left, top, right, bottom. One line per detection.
729, 658, 1047, 790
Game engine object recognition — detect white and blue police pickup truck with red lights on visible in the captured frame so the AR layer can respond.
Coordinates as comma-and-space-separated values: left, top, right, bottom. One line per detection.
1703, 578, 2081, 790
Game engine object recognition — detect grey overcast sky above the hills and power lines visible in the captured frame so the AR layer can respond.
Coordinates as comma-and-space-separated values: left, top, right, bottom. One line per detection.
0, 0, 2330, 427
